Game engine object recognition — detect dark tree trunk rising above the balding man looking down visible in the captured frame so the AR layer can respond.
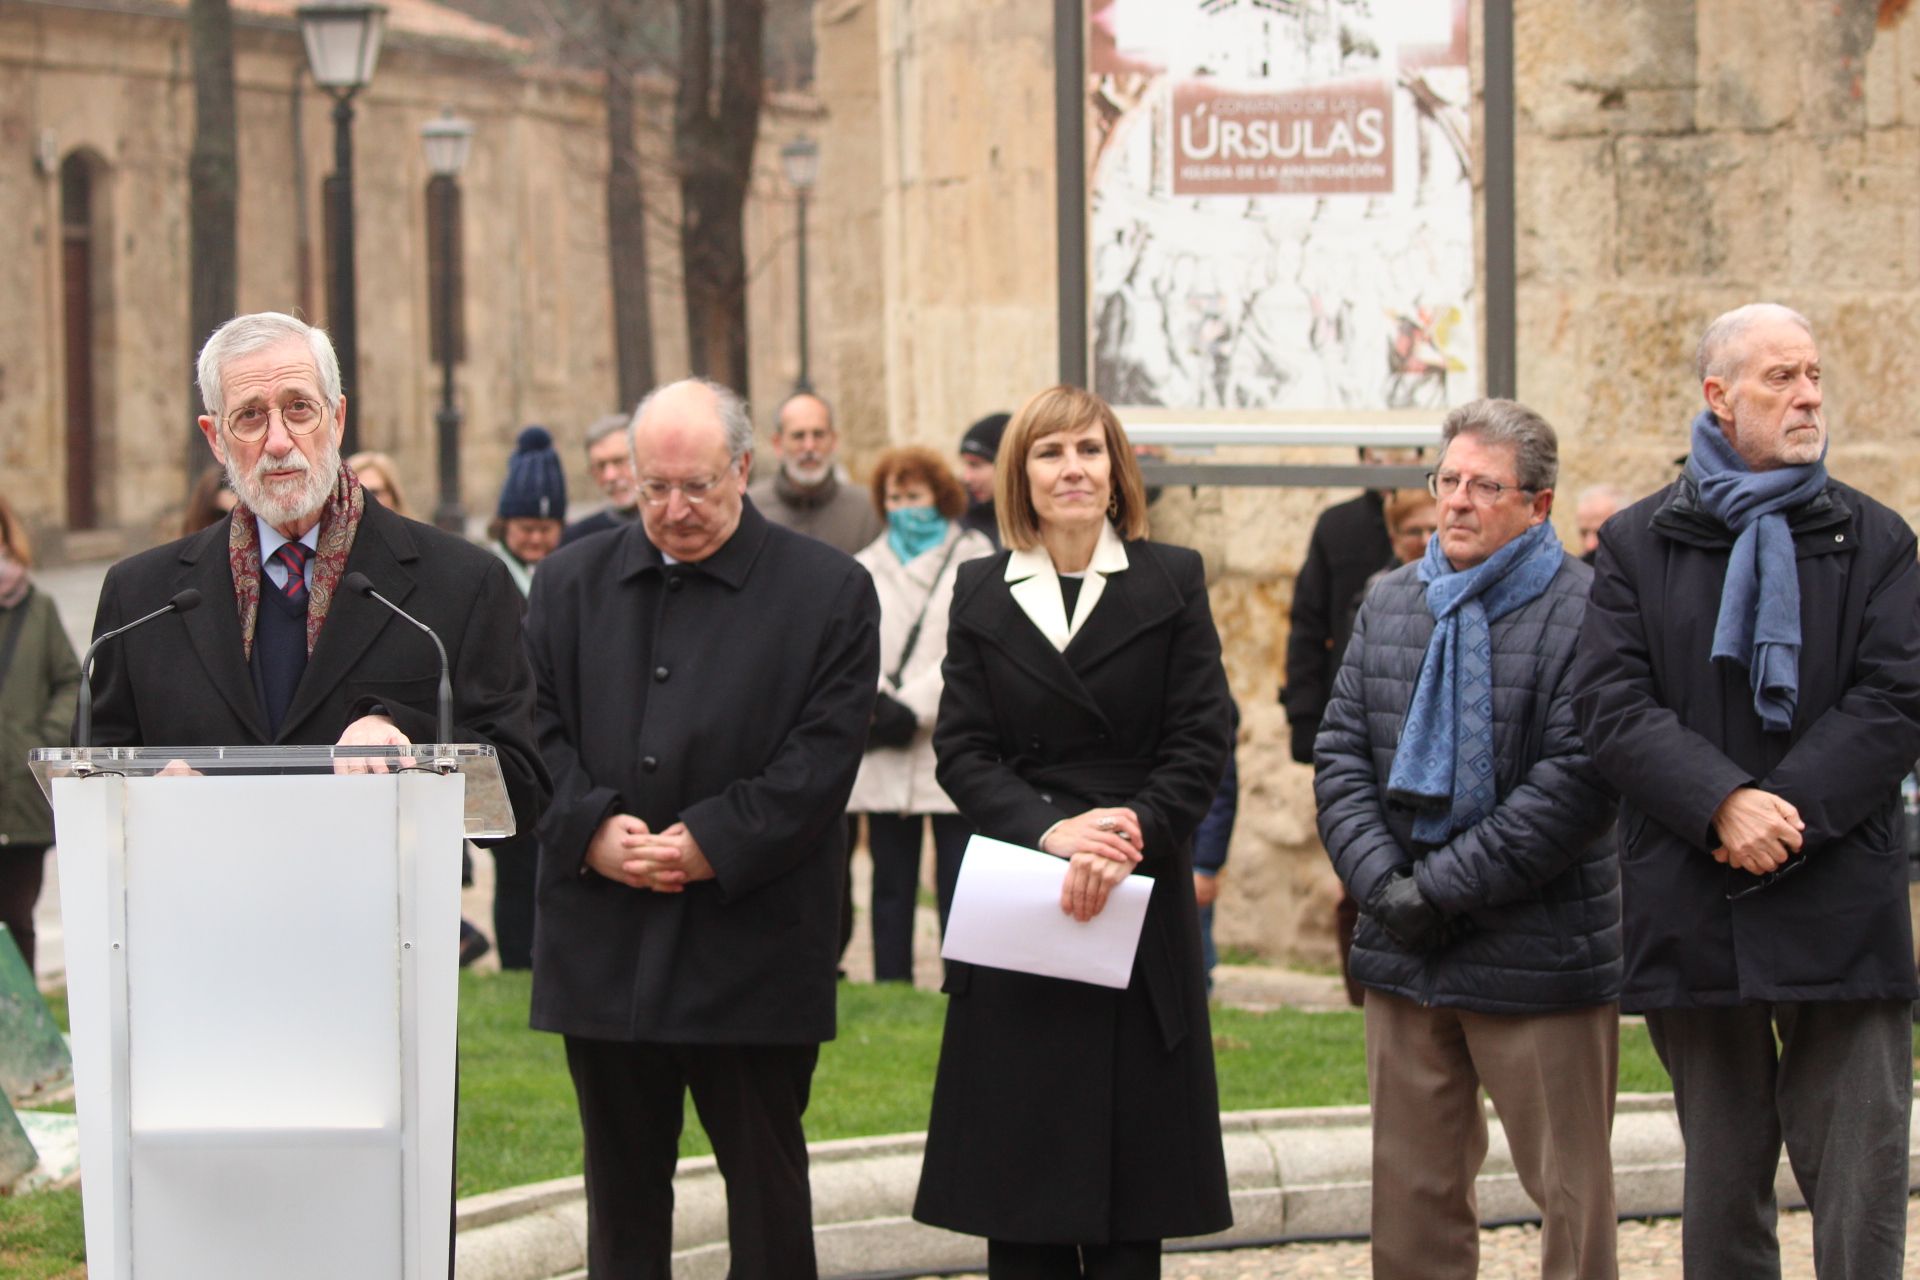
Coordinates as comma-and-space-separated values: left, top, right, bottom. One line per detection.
674, 0, 766, 395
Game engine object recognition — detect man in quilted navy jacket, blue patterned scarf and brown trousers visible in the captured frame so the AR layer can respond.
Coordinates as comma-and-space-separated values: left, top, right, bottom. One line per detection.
1313, 399, 1620, 1280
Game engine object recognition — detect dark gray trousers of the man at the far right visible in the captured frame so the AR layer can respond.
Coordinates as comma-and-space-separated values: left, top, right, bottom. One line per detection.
1647, 1000, 1912, 1280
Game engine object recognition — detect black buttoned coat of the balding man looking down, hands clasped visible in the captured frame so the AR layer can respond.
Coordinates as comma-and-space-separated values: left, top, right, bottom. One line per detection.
526, 503, 879, 1044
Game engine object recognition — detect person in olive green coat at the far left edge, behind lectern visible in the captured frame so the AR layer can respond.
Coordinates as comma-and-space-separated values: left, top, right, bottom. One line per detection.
0, 497, 81, 973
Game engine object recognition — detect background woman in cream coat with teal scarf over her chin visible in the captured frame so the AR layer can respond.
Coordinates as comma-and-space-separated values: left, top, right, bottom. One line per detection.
847, 447, 993, 983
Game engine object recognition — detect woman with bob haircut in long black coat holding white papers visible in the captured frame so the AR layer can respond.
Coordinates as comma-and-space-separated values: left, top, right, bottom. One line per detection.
914, 386, 1233, 1280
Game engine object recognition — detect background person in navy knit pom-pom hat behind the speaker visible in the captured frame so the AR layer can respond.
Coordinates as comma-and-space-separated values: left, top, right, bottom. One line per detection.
483, 426, 566, 969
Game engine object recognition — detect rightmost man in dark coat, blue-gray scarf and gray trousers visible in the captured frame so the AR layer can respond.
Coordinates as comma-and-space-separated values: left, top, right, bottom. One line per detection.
1574, 303, 1920, 1280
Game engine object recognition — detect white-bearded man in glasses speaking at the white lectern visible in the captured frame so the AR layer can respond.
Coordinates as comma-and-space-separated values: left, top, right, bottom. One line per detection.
92, 311, 549, 827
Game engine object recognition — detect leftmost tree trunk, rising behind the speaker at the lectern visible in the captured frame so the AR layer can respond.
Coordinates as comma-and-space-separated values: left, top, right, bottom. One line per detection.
186, 0, 240, 475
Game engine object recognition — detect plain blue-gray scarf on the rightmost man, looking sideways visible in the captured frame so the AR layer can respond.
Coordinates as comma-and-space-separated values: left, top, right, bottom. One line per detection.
1686, 409, 1826, 733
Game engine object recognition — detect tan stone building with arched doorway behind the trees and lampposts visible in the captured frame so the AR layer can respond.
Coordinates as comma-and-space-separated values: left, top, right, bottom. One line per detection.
0, 0, 837, 558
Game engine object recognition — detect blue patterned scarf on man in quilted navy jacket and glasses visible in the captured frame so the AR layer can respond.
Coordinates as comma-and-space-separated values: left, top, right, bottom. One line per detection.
1386, 522, 1567, 844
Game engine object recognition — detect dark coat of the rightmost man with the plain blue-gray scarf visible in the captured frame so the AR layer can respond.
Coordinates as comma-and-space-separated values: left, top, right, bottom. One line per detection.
1574, 478, 1920, 1009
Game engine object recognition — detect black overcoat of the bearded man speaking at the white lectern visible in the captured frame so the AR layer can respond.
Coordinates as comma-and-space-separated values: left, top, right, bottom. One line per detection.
94, 495, 551, 831
